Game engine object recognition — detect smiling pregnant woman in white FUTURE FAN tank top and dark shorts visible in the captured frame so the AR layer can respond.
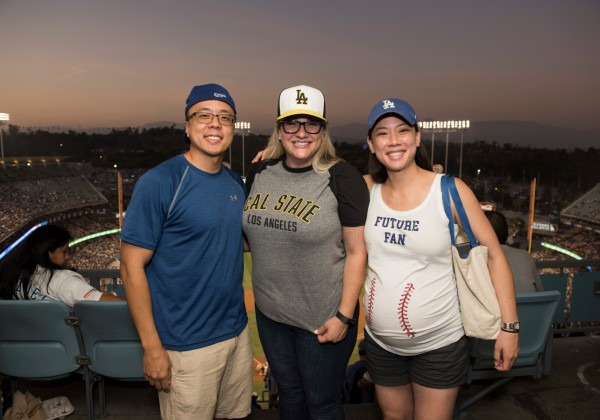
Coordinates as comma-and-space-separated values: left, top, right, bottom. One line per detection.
364, 98, 519, 419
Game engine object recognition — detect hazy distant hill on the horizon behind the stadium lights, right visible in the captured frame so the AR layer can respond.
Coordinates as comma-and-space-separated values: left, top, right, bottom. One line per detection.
331, 121, 600, 149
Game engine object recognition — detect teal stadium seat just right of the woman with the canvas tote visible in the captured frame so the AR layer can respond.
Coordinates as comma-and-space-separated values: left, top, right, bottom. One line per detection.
455, 290, 561, 415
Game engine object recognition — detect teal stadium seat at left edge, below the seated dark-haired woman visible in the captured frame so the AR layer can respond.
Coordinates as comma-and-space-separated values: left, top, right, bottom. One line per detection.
0, 300, 87, 406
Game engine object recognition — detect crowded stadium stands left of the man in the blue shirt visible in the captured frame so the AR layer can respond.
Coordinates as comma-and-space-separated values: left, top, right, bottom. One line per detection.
0, 161, 143, 262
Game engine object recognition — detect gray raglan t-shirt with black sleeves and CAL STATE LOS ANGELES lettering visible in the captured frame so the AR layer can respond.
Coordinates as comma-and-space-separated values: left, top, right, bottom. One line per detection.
243, 161, 369, 331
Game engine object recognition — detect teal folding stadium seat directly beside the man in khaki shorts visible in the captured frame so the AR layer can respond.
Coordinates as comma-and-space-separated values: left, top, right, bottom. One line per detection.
73, 301, 145, 417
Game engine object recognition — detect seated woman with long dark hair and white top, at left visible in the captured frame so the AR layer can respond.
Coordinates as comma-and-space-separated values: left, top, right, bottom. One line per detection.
0, 225, 124, 306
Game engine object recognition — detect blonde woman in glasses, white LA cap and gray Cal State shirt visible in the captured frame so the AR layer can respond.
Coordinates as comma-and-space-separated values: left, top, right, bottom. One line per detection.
243, 85, 369, 420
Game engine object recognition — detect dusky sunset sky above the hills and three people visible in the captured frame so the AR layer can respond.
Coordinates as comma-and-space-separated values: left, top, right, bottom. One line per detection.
0, 0, 600, 131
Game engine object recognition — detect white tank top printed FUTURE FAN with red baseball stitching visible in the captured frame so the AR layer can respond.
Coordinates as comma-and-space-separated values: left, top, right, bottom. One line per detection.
364, 175, 464, 356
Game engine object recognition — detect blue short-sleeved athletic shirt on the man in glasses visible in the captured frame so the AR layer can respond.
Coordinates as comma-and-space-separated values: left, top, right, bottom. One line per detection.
121, 155, 248, 351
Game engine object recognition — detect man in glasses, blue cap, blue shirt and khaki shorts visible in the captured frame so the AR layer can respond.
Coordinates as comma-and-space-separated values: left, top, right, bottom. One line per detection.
121, 84, 252, 420
